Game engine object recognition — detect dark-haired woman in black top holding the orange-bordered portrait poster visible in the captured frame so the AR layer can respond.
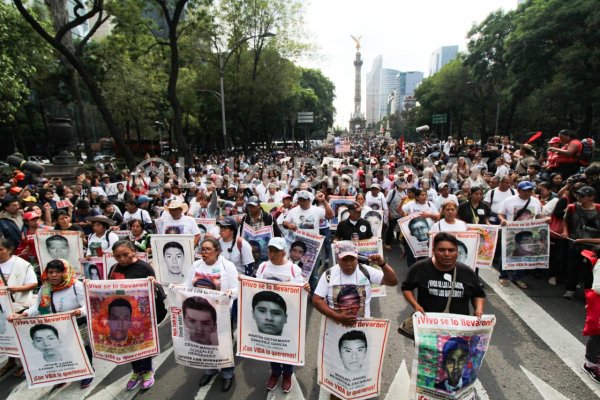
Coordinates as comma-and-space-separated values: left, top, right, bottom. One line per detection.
108, 240, 166, 390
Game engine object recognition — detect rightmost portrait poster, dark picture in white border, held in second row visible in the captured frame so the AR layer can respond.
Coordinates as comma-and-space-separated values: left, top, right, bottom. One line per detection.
502, 219, 550, 270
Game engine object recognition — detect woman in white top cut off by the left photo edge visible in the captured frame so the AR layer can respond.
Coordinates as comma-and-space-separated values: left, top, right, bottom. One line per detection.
0, 238, 37, 376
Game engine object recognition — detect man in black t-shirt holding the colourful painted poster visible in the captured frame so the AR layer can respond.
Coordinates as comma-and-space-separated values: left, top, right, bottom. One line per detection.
402, 232, 485, 318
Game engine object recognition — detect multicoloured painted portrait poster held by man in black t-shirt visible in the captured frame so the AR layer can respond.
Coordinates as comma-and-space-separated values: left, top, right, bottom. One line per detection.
409, 313, 496, 400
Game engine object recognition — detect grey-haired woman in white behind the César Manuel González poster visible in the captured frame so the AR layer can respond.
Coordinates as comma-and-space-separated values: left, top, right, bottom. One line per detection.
183, 238, 238, 392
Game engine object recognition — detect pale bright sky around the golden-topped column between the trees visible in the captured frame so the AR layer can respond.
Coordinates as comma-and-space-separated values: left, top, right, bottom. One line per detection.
299, 0, 517, 127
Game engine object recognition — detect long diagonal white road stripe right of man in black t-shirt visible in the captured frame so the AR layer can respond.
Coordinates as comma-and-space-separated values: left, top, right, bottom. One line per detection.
479, 269, 600, 397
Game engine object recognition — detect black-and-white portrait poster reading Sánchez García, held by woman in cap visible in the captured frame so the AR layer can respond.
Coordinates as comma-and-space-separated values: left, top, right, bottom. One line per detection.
237, 275, 307, 365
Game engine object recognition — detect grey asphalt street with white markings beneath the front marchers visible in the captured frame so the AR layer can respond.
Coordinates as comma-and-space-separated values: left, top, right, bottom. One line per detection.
0, 248, 600, 400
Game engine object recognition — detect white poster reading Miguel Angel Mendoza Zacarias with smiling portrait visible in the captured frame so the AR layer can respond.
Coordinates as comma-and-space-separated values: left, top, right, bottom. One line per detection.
317, 317, 390, 399
